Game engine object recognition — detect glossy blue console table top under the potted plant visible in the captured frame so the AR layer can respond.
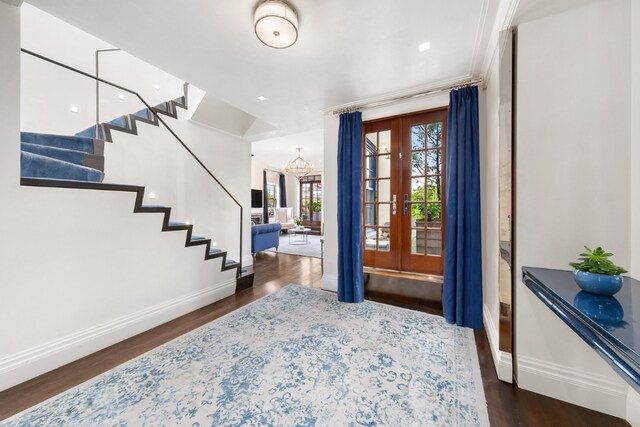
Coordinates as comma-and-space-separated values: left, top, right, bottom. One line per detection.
522, 267, 640, 392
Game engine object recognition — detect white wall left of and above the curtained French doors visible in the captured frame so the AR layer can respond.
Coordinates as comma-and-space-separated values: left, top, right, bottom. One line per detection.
322, 94, 449, 291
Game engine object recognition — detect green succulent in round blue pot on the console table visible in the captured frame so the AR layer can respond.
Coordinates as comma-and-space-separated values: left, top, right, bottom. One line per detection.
569, 246, 627, 295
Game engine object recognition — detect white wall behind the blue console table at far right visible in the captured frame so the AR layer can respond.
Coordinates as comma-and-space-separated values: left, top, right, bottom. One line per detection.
516, 1, 631, 417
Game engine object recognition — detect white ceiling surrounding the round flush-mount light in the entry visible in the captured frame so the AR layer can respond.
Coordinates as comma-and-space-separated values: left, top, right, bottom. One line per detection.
29, 0, 505, 140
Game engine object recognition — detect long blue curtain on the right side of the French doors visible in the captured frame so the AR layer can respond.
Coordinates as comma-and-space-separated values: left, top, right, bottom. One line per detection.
442, 86, 482, 328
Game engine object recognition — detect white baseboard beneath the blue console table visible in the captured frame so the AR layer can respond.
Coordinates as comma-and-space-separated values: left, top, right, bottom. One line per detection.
518, 355, 629, 418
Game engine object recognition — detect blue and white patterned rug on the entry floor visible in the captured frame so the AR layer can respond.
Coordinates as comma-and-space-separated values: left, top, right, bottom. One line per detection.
0, 286, 489, 427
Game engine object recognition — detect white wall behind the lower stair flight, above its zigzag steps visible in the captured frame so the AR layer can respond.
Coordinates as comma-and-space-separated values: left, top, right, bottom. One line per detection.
104, 95, 251, 266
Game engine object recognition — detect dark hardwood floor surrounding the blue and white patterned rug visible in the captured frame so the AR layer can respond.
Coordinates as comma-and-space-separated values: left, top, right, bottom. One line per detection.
0, 252, 629, 427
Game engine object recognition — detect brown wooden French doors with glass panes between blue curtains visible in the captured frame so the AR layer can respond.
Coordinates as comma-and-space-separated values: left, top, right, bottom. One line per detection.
363, 108, 447, 276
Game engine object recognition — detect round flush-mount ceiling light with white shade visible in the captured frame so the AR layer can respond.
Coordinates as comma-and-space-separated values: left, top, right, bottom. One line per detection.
253, 0, 298, 49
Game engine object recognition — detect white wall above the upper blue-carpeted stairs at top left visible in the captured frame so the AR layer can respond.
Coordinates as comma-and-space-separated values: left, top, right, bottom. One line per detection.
21, 4, 190, 134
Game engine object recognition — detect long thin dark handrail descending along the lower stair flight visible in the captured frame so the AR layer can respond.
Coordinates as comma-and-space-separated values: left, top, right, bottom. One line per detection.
20, 49, 244, 276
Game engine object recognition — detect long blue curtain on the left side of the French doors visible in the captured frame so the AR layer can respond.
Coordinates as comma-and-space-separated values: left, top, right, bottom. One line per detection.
338, 112, 364, 302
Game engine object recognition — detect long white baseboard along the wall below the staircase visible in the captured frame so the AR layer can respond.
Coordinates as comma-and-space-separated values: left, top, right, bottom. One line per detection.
0, 279, 236, 391
